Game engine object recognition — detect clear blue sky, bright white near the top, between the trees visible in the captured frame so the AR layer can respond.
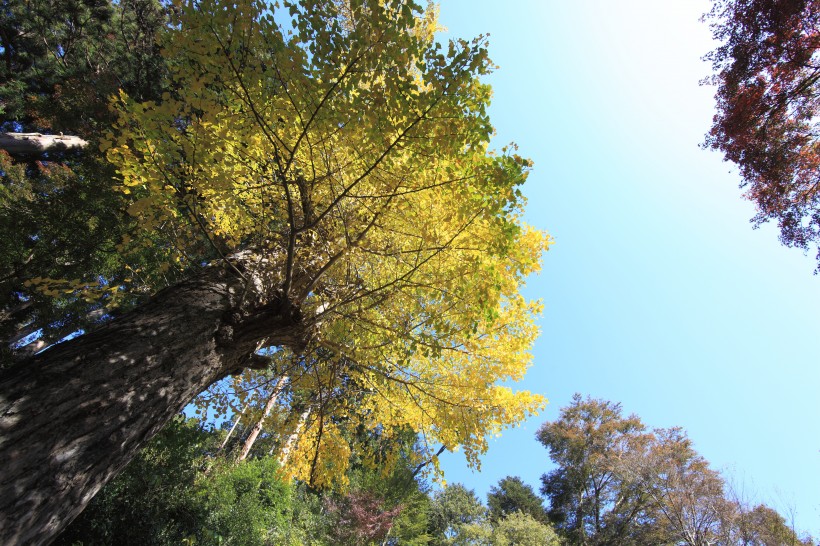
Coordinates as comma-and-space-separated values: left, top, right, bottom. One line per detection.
441, 0, 820, 536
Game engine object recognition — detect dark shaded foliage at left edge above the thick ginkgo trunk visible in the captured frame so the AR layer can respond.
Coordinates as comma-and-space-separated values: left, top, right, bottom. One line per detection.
0, 0, 183, 365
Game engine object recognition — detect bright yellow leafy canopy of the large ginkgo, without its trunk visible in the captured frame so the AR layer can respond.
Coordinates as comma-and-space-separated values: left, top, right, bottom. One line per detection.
102, 1, 548, 477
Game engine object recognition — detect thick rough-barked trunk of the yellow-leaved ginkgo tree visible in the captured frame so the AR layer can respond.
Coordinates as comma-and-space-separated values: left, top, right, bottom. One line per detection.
0, 262, 306, 546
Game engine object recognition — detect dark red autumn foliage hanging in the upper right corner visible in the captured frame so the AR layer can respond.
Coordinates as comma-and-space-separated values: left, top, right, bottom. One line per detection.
706, 0, 820, 260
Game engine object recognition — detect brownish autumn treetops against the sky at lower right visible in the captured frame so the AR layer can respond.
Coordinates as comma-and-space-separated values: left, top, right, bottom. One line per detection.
537, 394, 813, 546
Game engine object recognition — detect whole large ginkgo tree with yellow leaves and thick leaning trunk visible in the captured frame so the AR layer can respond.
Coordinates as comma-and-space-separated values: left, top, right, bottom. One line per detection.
0, 0, 549, 544
